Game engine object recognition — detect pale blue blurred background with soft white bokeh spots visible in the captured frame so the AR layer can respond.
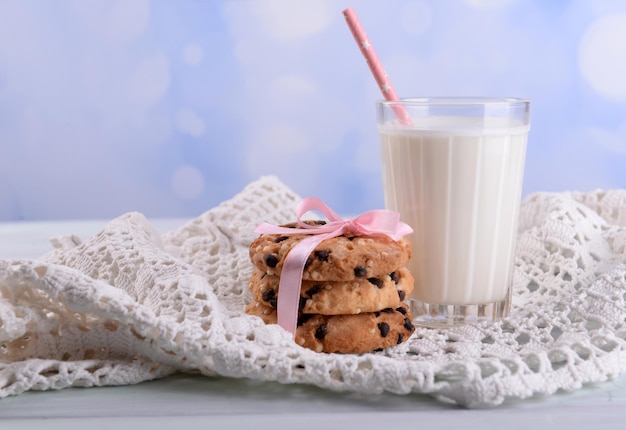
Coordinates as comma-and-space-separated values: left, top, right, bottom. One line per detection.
0, 0, 626, 220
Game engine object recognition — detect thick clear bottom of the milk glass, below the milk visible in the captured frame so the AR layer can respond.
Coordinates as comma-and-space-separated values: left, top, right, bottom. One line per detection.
409, 289, 511, 328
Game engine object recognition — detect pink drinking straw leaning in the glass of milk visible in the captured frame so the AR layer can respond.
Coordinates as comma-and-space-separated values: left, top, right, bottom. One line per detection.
343, 7, 411, 125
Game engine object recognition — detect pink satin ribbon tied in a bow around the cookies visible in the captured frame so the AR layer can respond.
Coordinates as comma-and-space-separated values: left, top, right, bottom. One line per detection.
254, 197, 413, 336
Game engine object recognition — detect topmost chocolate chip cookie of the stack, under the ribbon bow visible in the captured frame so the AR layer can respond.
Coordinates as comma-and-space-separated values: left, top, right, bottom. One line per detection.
250, 221, 412, 281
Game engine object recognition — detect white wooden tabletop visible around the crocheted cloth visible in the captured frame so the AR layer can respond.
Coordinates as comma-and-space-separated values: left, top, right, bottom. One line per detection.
0, 220, 626, 430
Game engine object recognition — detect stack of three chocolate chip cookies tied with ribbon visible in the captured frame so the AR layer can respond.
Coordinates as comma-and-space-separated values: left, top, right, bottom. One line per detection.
246, 221, 414, 353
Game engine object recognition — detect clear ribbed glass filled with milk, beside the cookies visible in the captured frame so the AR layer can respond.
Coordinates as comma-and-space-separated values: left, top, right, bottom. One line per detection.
377, 97, 530, 326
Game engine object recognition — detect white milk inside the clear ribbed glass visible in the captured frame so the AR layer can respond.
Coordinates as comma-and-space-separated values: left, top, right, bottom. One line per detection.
379, 118, 528, 305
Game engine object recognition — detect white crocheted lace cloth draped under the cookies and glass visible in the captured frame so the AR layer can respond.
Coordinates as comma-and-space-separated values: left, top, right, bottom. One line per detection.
0, 177, 626, 407
